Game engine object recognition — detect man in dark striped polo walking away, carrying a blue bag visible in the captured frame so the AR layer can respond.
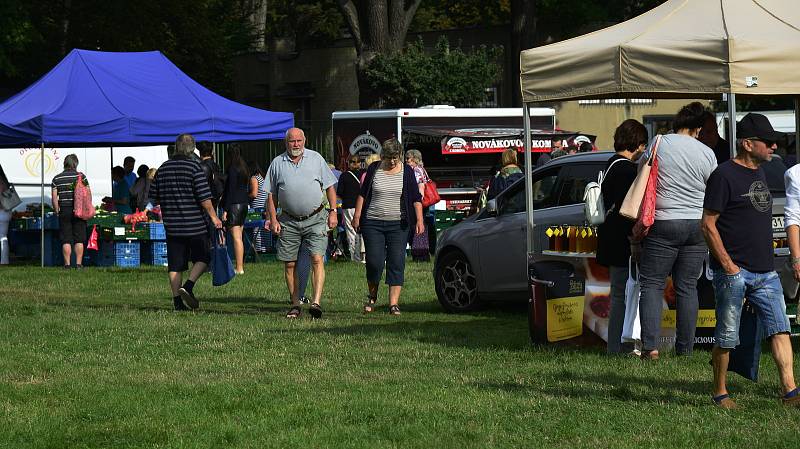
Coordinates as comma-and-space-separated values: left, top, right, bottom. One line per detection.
150, 134, 222, 310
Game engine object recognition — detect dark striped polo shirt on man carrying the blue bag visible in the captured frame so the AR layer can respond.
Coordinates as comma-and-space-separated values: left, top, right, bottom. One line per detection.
150, 157, 211, 237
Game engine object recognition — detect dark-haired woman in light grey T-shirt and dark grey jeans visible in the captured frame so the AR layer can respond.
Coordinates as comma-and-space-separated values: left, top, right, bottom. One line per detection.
631, 102, 717, 360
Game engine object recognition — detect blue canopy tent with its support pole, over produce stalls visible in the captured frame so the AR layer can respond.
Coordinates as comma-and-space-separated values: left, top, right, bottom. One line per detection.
0, 50, 294, 266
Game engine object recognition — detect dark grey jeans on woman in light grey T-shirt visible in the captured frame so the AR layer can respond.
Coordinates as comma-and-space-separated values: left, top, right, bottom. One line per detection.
639, 220, 708, 354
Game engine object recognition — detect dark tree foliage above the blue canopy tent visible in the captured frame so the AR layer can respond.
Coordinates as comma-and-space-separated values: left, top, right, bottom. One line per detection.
0, 0, 257, 94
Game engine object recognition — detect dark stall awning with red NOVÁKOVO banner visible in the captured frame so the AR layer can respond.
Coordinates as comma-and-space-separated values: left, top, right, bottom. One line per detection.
404, 126, 596, 154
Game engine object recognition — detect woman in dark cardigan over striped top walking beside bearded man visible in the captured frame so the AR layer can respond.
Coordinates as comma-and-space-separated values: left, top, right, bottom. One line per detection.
353, 139, 425, 315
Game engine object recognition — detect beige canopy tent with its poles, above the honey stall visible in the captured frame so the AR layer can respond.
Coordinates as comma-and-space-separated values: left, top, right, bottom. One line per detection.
520, 0, 800, 252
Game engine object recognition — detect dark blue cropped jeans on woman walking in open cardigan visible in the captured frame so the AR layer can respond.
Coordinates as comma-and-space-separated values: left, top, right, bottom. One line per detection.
361, 219, 408, 286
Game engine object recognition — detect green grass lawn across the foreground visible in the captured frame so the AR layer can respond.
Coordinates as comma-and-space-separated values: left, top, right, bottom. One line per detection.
0, 263, 800, 448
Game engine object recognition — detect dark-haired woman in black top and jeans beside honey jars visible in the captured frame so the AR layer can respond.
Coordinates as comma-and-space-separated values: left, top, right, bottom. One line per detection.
597, 119, 647, 354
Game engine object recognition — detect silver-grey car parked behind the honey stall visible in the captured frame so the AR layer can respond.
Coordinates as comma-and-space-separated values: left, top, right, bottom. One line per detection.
434, 151, 788, 312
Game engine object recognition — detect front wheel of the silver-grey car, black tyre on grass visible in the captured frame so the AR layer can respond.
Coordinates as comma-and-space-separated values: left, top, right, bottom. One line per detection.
435, 251, 479, 312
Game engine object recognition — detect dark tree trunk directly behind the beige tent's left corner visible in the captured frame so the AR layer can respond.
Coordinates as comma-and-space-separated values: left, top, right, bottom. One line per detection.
505, 0, 536, 107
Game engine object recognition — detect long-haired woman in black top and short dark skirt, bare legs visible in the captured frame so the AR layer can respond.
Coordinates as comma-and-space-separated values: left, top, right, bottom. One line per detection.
220, 145, 250, 274
